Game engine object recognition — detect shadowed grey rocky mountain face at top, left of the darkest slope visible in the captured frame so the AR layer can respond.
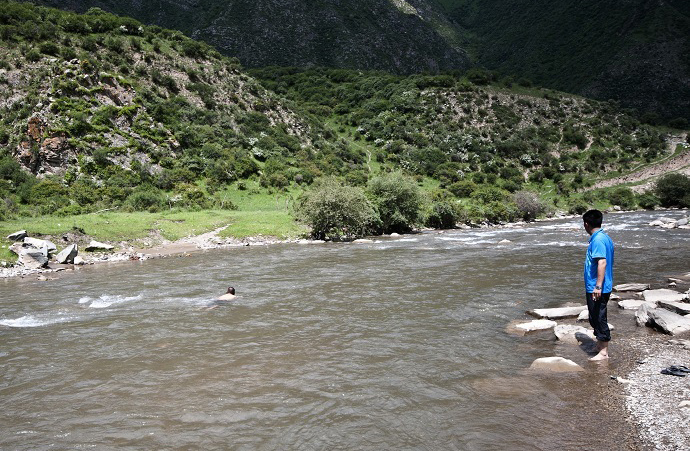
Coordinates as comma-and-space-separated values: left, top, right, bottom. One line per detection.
33, 0, 469, 73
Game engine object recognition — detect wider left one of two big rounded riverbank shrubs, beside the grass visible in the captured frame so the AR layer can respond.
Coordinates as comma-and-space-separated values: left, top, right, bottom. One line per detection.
296, 177, 380, 239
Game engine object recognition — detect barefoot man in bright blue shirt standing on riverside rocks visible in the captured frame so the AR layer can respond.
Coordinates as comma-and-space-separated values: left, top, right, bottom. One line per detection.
582, 210, 613, 361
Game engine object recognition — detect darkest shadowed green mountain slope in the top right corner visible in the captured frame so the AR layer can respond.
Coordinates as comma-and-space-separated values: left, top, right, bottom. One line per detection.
439, 0, 690, 124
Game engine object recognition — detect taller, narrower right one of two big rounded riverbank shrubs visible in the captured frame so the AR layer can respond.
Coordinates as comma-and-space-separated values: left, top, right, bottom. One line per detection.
367, 172, 423, 233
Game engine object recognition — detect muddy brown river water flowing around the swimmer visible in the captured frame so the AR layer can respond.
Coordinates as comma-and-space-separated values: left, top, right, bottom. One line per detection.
0, 211, 690, 450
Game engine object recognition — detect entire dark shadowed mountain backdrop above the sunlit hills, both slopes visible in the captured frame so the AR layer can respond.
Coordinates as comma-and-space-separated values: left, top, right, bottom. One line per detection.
30, 0, 690, 125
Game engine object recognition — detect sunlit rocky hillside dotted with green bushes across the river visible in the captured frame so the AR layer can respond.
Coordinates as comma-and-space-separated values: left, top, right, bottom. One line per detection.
0, 1, 680, 233
